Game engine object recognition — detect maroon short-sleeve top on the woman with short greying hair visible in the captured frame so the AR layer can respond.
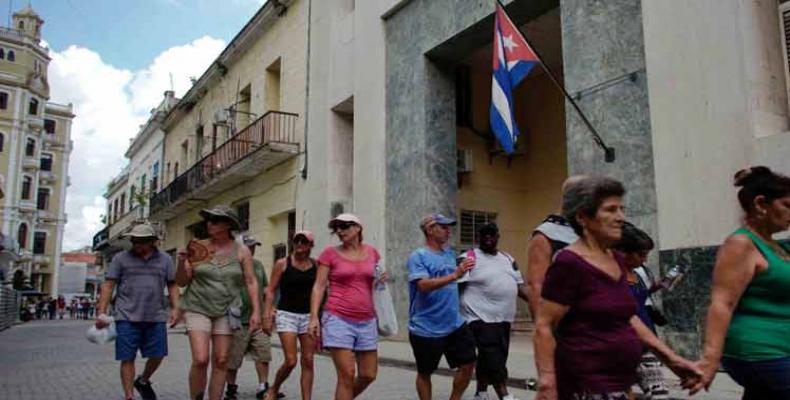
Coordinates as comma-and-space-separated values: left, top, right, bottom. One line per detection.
541, 250, 642, 399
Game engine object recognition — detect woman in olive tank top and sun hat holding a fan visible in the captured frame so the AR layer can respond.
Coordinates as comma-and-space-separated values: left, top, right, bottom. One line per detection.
176, 205, 261, 400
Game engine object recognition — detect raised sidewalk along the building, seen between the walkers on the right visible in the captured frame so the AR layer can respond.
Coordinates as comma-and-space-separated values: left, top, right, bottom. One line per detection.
368, 334, 743, 400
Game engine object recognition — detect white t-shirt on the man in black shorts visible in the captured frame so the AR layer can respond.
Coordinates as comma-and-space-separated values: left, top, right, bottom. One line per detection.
459, 249, 524, 323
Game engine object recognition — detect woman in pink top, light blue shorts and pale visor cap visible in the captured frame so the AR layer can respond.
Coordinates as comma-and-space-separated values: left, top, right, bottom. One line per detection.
309, 214, 386, 400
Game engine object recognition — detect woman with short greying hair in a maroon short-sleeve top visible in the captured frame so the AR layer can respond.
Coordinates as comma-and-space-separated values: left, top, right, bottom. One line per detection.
534, 177, 698, 400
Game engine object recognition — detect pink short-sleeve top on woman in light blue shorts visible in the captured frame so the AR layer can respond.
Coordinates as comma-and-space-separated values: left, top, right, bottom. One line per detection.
318, 245, 381, 322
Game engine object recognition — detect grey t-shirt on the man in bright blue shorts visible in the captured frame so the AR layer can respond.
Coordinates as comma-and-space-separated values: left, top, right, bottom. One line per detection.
106, 250, 175, 322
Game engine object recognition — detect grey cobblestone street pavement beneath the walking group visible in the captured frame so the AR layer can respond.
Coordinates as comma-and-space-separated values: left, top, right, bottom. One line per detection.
0, 320, 532, 400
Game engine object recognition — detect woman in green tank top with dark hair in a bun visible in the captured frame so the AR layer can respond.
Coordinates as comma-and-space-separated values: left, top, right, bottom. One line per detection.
692, 167, 790, 400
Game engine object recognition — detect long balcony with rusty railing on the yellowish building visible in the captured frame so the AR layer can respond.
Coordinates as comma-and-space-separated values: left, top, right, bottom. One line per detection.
151, 111, 300, 220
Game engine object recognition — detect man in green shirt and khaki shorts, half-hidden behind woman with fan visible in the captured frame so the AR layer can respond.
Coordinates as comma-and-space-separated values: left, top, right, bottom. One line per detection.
225, 235, 272, 400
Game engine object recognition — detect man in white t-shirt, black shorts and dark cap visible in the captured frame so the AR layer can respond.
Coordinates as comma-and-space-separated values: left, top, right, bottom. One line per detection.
458, 223, 527, 400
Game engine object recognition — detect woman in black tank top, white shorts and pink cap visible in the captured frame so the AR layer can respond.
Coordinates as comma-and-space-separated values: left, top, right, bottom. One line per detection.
263, 230, 318, 400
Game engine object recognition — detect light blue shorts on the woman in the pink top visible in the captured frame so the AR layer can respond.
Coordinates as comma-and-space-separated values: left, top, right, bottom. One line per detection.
321, 312, 379, 351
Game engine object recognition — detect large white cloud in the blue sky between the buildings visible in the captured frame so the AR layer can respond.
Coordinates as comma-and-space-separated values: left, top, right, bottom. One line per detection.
49, 36, 225, 250
